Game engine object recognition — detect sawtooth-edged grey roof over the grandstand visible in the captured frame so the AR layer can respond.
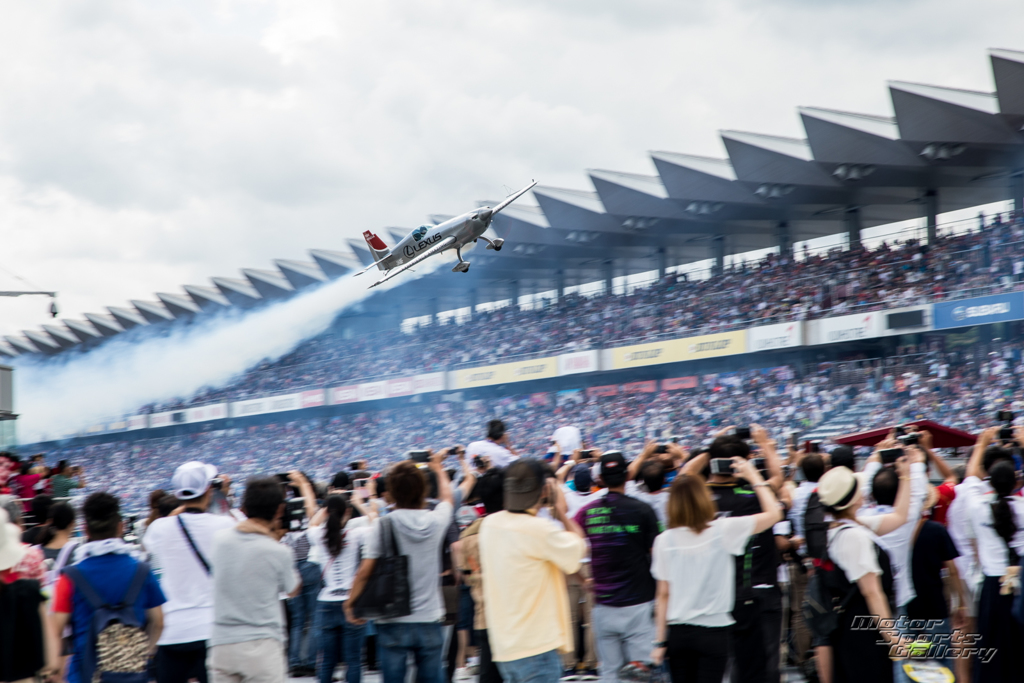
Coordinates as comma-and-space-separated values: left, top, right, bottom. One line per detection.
6, 49, 1024, 358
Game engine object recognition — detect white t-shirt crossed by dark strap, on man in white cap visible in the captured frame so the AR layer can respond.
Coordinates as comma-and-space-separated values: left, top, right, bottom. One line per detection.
142, 512, 237, 645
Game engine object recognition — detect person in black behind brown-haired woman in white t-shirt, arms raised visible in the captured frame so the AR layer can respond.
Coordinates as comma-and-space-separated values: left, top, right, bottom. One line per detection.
683, 425, 782, 683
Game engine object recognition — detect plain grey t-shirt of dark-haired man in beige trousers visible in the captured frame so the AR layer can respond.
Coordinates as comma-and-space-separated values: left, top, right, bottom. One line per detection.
208, 527, 299, 646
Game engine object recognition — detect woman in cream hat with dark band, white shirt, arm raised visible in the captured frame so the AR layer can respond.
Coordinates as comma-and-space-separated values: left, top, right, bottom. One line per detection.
818, 457, 910, 683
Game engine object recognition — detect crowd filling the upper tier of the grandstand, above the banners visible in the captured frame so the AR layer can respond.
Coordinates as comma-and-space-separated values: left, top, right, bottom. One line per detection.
146, 211, 1024, 412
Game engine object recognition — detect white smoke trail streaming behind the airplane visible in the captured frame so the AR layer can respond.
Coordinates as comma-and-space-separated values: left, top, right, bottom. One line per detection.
14, 256, 447, 443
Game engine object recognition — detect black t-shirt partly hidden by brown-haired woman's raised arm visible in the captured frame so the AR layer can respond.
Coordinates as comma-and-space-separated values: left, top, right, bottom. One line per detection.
708, 480, 779, 598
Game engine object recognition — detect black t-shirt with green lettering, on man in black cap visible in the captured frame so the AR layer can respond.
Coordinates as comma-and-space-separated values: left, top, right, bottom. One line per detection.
575, 492, 659, 607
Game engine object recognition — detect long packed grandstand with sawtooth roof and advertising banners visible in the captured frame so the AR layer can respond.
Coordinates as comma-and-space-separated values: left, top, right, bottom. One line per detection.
9, 50, 1024, 503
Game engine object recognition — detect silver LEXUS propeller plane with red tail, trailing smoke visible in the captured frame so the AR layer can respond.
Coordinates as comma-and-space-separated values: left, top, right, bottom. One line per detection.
355, 180, 537, 289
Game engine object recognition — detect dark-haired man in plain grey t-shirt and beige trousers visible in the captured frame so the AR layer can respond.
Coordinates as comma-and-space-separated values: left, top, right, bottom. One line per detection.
207, 477, 302, 683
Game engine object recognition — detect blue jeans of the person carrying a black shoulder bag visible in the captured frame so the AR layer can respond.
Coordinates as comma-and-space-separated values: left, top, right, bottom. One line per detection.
377, 622, 444, 683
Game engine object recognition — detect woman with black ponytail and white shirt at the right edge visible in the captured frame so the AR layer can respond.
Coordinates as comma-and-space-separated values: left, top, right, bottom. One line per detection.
965, 427, 1024, 683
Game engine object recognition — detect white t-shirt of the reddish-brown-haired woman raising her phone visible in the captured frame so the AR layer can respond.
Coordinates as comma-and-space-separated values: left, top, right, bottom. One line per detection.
650, 516, 754, 627
